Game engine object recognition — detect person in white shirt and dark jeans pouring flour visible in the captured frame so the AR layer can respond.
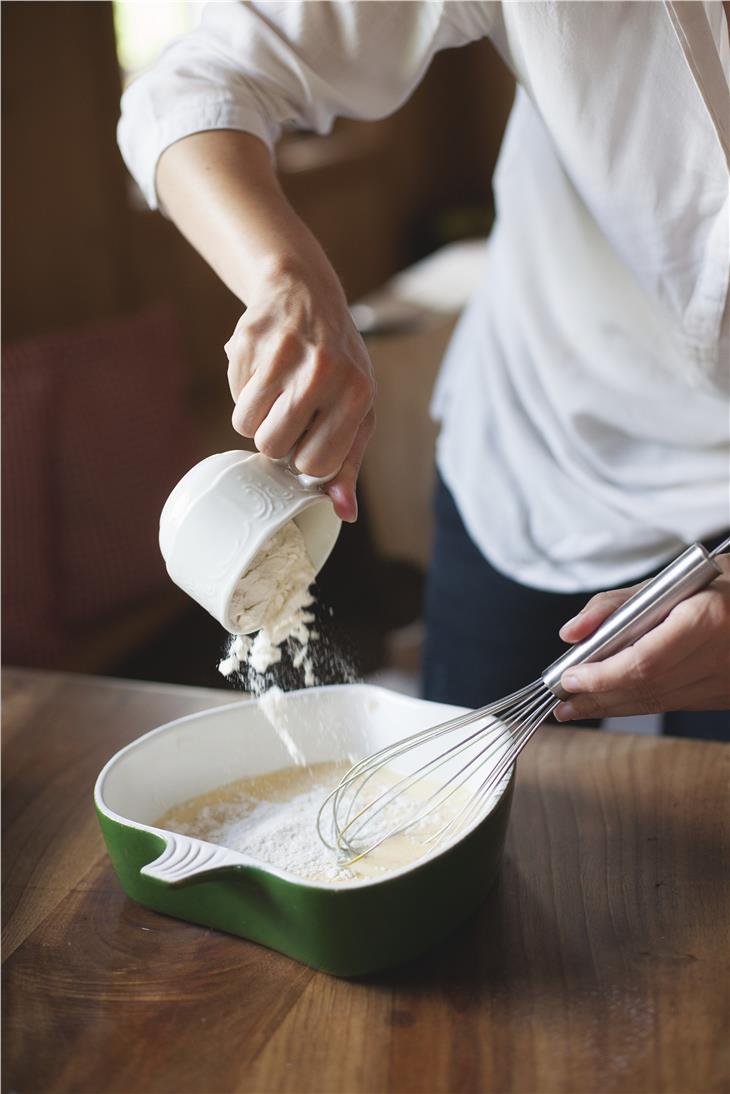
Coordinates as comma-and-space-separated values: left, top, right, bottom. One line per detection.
119, 0, 730, 736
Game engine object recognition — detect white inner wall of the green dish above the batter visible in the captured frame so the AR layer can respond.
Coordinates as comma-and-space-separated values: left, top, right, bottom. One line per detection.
95, 684, 512, 880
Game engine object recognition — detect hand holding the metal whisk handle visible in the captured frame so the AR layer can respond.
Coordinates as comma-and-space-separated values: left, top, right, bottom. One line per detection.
555, 555, 730, 722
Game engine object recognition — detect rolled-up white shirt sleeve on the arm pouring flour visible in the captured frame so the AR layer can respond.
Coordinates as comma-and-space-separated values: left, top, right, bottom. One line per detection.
118, 0, 498, 208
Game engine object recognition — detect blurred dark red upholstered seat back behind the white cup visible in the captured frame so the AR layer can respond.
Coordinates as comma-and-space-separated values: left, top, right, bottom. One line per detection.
2, 305, 198, 668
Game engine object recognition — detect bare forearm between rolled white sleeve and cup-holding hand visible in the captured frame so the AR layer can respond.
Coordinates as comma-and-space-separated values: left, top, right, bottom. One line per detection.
157, 129, 343, 304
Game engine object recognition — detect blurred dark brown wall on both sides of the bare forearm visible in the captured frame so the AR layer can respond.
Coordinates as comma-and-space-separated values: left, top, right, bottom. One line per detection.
1, 0, 512, 379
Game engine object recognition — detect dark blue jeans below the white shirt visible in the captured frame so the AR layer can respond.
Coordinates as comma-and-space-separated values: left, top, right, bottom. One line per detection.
421, 479, 730, 741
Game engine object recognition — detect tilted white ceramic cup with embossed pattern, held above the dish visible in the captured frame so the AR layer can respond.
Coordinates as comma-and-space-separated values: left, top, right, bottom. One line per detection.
160, 450, 341, 635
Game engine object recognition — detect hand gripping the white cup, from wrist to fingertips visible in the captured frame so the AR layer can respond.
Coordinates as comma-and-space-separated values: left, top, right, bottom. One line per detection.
225, 260, 375, 521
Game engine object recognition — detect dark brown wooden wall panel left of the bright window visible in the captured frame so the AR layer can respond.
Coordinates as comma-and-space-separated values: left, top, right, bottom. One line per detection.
1, 2, 136, 340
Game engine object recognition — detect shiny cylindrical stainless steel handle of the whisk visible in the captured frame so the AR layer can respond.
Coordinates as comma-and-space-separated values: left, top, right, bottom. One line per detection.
542, 544, 722, 699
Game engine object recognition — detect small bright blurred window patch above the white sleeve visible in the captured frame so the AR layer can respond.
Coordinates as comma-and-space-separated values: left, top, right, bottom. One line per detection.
112, 0, 204, 86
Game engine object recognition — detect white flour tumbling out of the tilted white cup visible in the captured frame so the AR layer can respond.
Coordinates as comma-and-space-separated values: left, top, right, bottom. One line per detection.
218, 521, 318, 682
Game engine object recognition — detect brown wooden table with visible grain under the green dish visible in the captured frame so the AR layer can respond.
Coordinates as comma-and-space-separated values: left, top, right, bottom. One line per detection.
3, 671, 730, 1094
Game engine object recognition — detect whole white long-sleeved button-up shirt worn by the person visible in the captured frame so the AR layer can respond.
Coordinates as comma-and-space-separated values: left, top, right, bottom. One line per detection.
119, 0, 730, 591
